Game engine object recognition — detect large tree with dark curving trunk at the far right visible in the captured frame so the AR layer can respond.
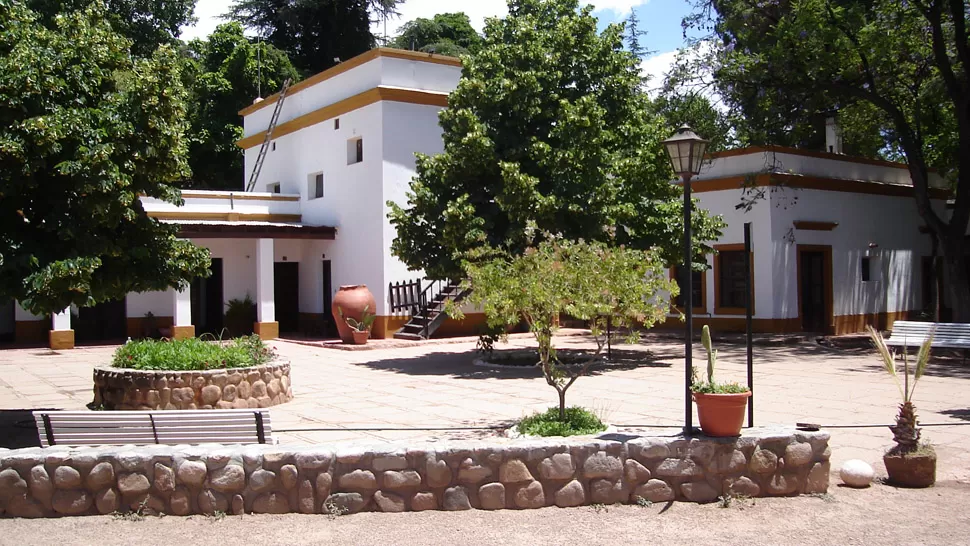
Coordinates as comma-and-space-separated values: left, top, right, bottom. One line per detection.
696, 0, 970, 322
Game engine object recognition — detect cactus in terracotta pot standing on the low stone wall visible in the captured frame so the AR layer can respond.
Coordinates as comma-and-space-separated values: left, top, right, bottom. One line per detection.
690, 325, 751, 436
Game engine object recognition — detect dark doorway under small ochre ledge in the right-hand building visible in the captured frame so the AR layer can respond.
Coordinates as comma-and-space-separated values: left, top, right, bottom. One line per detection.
798, 245, 834, 333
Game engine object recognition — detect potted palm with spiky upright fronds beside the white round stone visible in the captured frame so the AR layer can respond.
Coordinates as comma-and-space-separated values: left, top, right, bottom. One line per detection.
869, 326, 936, 487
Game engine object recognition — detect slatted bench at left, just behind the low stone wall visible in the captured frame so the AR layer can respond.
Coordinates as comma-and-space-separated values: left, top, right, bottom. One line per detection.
33, 409, 274, 447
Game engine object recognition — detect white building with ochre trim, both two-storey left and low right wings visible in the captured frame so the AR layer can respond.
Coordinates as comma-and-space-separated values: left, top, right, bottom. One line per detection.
0, 45, 945, 348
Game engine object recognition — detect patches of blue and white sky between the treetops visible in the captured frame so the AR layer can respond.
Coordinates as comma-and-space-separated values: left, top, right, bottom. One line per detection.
182, 0, 691, 87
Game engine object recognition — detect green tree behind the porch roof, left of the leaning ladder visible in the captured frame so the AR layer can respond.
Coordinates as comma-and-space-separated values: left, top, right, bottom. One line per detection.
183, 22, 299, 189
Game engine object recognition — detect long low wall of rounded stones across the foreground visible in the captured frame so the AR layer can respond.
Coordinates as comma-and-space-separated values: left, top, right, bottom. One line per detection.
0, 429, 830, 517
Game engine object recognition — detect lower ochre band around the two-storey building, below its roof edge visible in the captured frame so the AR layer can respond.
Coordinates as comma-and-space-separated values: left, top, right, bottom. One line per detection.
236, 87, 448, 150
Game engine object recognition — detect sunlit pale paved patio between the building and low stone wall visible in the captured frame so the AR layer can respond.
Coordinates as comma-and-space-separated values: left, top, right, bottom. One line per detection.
0, 335, 970, 481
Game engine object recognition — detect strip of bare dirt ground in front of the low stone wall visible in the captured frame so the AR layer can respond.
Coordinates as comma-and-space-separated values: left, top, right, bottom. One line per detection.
0, 481, 970, 546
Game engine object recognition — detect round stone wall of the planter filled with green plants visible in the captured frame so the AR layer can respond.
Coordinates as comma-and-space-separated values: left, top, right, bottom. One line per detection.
93, 362, 293, 410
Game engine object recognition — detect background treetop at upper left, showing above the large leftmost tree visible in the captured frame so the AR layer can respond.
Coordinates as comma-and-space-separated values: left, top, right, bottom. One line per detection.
27, 0, 197, 57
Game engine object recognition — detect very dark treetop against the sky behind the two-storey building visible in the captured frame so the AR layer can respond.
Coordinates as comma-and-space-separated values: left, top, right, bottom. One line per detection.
228, 0, 401, 74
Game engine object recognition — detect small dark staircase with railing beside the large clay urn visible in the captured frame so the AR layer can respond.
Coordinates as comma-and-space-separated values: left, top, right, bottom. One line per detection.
389, 280, 471, 340
